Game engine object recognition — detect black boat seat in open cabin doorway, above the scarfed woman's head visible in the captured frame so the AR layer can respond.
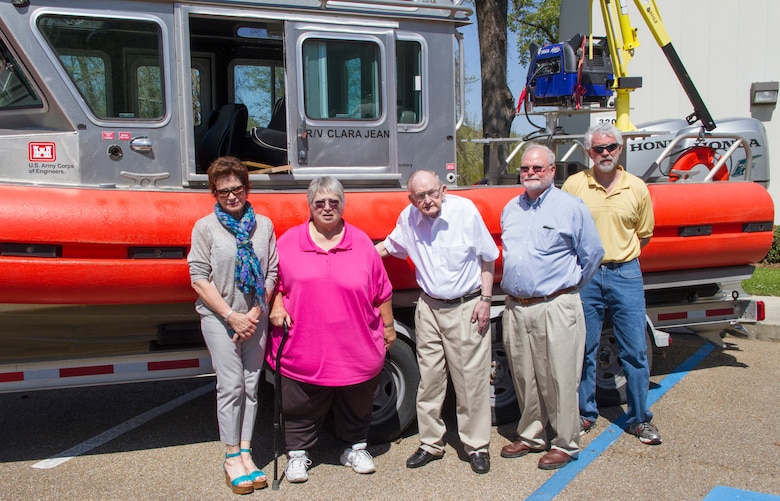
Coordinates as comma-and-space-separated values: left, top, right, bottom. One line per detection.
198, 103, 249, 172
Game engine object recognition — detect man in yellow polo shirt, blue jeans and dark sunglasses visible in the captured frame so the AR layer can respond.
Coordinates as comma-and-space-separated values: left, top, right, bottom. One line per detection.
563, 123, 661, 445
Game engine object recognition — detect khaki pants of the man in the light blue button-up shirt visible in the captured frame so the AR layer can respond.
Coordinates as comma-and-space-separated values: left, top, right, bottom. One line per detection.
503, 293, 585, 457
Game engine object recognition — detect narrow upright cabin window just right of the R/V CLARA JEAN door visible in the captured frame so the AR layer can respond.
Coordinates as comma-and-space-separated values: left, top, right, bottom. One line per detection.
395, 40, 423, 124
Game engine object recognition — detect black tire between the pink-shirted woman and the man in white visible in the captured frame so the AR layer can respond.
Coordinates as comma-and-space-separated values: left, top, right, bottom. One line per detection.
368, 336, 420, 443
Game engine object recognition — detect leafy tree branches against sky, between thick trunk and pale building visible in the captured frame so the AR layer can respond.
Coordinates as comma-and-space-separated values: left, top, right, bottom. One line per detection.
508, 0, 561, 66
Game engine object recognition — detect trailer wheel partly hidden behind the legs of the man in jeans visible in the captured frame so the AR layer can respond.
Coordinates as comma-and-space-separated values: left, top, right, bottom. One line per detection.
596, 325, 653, 407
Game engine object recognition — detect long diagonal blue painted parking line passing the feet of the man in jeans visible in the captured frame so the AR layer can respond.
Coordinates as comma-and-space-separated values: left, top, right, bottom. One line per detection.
527, 343, 714, 501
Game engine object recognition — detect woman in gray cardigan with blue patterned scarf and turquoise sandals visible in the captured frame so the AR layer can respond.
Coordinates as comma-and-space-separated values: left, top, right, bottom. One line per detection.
187, 157, 278, 494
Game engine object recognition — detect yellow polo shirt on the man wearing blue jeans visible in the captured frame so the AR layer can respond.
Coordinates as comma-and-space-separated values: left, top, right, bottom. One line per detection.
562, 166, 655, 263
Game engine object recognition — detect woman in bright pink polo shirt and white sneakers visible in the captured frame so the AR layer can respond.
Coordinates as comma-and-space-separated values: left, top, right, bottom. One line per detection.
266, 177, 395, 482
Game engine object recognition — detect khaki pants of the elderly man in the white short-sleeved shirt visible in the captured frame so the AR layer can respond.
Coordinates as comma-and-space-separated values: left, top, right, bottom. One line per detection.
415, 294, 491, 455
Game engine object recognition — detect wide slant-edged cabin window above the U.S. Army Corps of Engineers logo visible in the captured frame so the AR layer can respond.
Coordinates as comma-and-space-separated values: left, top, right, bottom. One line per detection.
38, 14, 165, 120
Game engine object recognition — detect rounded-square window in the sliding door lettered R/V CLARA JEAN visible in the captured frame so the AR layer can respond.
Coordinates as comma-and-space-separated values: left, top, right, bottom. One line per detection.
303, 38, 382, 120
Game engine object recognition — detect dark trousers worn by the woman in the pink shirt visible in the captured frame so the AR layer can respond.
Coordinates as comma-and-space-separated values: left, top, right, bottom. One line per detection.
282, 375, 379, 450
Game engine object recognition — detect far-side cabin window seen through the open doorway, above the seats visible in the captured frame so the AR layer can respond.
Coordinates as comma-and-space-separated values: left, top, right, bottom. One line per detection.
233, 61, 284, 130
